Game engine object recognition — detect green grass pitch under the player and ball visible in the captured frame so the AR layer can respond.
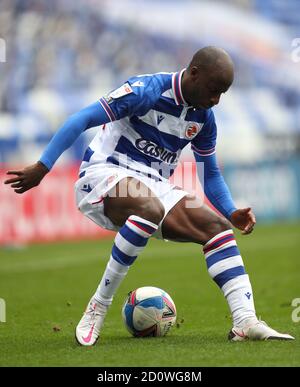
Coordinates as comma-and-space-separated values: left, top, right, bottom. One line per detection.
0, 223, 300, 367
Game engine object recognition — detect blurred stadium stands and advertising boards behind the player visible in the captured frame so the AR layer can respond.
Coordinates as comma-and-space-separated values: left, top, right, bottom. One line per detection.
0, 0, 300, 245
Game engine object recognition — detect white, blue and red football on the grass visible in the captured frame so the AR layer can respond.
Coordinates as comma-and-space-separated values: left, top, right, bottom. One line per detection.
122, 286, 176, 337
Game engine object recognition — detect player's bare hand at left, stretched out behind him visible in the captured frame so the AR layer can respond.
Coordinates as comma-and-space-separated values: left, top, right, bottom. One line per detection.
4, 161, 49, 194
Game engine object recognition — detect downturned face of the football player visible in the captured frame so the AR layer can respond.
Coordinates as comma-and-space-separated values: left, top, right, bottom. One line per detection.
189, 68, 232, 109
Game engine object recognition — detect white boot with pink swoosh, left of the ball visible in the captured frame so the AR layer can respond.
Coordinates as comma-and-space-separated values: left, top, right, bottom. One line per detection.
75, 298, 108, 346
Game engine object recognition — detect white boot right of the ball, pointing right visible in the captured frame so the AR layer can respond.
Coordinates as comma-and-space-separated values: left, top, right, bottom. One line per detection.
228, 319, 295, 341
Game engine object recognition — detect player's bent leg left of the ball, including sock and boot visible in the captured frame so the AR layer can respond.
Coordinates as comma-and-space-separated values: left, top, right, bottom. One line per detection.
76, 178, 164, 346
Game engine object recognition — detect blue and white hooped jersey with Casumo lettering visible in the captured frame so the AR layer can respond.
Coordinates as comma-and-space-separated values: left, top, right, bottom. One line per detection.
80, 69, 217, 178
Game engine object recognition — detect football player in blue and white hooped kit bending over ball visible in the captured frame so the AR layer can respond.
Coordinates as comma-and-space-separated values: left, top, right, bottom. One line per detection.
5, 46, 294, 346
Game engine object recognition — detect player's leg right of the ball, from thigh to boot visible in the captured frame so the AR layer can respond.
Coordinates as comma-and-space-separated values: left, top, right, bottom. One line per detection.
162, 197, 293, 341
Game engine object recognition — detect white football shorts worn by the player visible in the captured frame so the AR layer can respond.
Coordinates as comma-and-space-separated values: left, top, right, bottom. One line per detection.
75, 164, 189, 239
